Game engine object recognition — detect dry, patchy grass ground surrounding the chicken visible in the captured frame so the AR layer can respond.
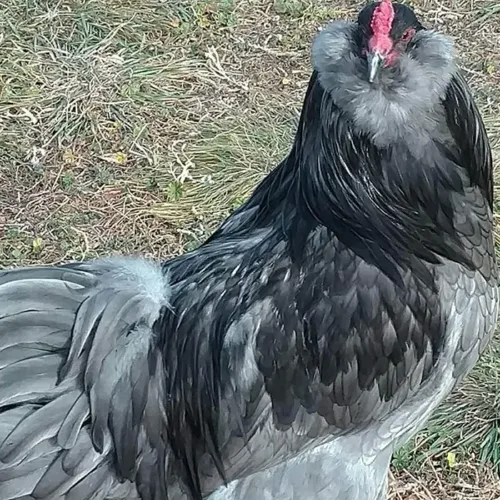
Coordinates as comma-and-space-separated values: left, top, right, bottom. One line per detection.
0, 0, 500, 500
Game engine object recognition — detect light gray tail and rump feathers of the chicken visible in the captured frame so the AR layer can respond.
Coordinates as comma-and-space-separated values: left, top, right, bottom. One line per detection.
0, 258, 170, 500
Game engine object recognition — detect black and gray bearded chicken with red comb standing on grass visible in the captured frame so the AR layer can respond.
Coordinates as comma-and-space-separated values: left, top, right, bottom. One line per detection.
0, 0, 498, 500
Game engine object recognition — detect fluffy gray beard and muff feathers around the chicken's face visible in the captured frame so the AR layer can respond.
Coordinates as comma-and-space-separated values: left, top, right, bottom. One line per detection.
312, 12, 456, 146
